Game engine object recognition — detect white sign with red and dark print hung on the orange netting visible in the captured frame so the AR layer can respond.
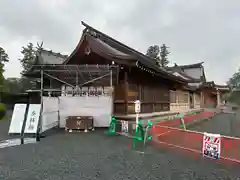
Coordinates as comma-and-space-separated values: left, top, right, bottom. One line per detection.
202, 133, 221, 159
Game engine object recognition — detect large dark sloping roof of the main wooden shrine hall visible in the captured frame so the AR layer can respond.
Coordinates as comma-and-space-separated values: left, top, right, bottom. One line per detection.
64, 22, 186, 83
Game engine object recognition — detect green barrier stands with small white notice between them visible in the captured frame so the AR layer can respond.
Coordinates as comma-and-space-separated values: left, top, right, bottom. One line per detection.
107, 116, 152, 148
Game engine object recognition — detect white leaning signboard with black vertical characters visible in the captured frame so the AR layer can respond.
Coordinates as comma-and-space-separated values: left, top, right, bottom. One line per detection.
24, 104, 41, 133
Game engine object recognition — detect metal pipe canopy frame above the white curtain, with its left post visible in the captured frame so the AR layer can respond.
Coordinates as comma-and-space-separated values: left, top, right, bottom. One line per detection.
28, 64, 118, 138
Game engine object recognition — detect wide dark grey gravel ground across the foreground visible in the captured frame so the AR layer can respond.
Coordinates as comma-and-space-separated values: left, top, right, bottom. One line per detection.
0, 121, 240, 180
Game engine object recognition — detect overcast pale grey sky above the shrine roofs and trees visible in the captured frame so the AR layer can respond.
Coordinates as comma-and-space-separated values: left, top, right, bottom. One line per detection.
0, 0, 240, 83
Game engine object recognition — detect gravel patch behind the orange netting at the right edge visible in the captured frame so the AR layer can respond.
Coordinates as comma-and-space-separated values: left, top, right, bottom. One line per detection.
189, 112, 240, 137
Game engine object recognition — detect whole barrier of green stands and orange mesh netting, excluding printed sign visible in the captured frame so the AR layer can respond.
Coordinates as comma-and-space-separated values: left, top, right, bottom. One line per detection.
107, 110, 240, 163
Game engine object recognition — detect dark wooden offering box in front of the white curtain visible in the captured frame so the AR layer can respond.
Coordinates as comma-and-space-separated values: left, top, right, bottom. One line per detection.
66, 116, 94, 131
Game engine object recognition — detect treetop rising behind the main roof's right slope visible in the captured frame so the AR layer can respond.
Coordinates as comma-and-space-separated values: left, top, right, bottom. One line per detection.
146, 44, 170, 67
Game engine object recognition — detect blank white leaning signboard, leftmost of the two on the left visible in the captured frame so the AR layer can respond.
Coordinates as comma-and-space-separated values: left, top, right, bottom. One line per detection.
8, 104, 27, 134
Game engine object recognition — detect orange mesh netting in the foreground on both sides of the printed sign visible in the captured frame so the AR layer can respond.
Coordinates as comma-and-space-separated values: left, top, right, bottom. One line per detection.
152, 125, 240, 163
